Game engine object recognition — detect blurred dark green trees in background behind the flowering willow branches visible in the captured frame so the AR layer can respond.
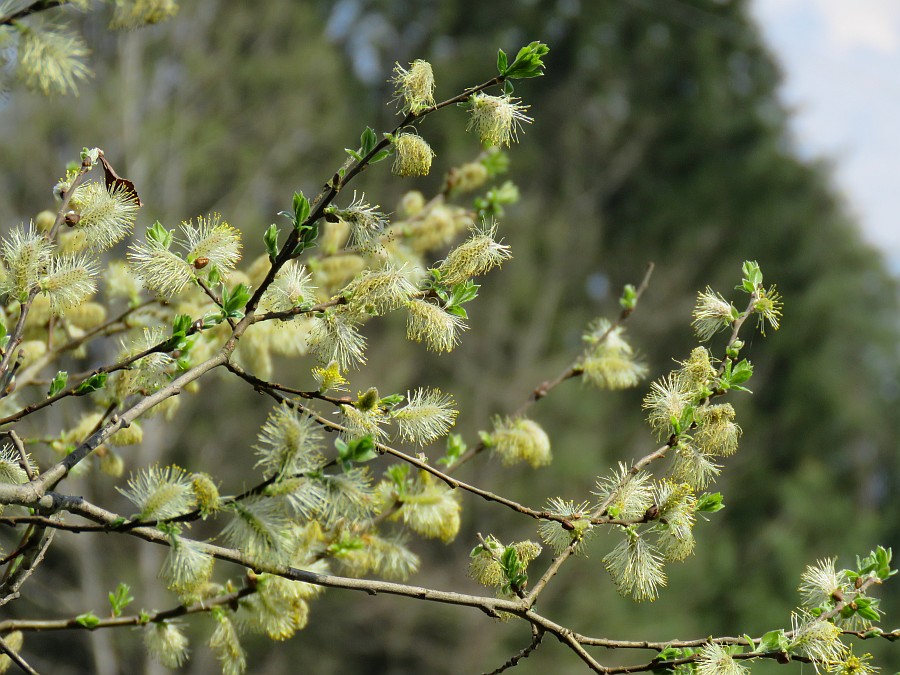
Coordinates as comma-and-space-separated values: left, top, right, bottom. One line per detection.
0, 0, 900, 675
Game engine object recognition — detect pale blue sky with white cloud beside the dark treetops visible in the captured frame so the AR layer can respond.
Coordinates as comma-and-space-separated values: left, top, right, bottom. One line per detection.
753, 0, 900, 272
